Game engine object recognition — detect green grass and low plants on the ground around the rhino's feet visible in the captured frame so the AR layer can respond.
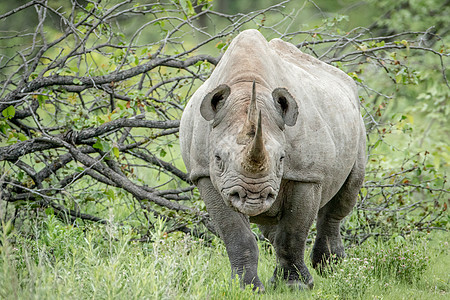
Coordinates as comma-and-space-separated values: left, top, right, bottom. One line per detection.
0, 216, 450, 299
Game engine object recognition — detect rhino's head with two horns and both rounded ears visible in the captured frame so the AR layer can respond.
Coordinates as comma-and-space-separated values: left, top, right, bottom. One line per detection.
200, 82, 298, 216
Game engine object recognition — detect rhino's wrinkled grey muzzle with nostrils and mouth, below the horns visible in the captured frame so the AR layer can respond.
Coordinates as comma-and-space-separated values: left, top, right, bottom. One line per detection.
225, 186, 277, 217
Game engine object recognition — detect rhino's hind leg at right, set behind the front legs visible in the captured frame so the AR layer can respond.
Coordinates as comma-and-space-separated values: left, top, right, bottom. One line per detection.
311, 152, 364, 273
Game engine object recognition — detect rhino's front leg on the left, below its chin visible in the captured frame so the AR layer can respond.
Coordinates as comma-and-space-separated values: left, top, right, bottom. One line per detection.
197, 177, 264, 292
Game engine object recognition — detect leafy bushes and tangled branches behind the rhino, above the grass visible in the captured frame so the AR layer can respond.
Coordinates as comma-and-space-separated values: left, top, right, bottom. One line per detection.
0, 0, 450, 245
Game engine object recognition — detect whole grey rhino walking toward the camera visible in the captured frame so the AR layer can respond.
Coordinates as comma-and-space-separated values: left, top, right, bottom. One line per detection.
180, 30, 365, 291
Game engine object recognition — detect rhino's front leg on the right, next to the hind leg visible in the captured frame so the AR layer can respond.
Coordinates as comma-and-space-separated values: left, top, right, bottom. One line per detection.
269, 182, 321, 289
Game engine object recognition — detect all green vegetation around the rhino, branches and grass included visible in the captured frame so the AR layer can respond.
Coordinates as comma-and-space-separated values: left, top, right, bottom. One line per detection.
0, 0, 450, 299
